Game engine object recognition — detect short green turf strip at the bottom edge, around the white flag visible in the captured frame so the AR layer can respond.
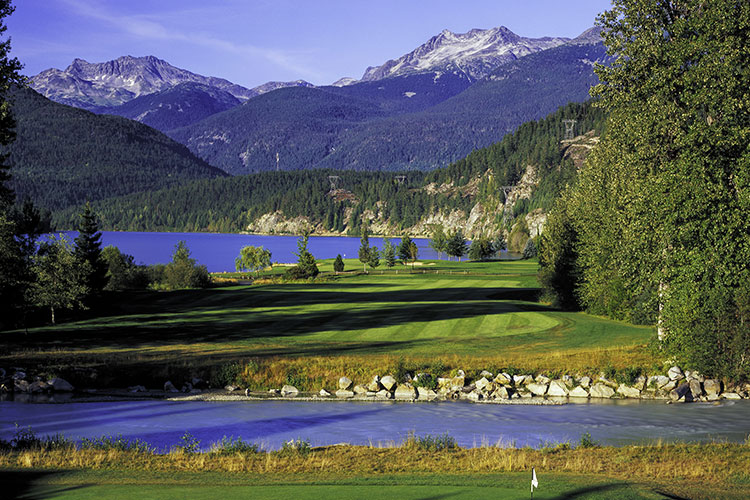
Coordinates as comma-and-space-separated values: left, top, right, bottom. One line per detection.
0, 471, 704, 500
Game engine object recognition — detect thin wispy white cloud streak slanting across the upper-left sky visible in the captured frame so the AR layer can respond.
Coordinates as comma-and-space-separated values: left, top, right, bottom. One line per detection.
64, 0, 321, 79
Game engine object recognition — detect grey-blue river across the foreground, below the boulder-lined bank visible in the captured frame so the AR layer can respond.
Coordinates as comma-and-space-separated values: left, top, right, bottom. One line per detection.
0, 400, 750, 449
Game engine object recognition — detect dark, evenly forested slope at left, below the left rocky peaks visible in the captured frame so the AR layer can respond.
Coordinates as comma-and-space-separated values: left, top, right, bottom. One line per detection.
7, 89, 226, 210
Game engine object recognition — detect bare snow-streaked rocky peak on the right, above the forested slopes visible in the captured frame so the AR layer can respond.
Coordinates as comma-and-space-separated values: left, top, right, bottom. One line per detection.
360, 26, 569, 83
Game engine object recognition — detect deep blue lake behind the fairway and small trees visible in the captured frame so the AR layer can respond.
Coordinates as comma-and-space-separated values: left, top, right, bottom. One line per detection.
57, 231, 458, 272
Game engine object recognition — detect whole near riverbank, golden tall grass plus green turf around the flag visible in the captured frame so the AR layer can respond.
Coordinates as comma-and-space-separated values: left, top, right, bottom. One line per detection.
0, 444, 750, 499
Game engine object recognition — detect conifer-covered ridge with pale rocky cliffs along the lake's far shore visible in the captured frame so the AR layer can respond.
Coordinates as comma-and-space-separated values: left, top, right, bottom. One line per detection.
55, 103, 604, 238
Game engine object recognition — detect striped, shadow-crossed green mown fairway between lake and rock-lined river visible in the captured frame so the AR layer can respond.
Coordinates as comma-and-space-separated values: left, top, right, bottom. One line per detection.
3, 260, 654, 378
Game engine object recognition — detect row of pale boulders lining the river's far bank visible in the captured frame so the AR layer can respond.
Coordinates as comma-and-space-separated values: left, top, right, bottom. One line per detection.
268, 366, 750, 402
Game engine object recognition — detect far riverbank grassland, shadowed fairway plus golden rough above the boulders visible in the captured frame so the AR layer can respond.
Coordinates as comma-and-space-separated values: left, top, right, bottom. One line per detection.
0, 261, 658, 390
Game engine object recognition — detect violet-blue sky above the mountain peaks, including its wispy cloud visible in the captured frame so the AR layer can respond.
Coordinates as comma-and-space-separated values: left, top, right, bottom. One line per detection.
7, 0, 610, 87
